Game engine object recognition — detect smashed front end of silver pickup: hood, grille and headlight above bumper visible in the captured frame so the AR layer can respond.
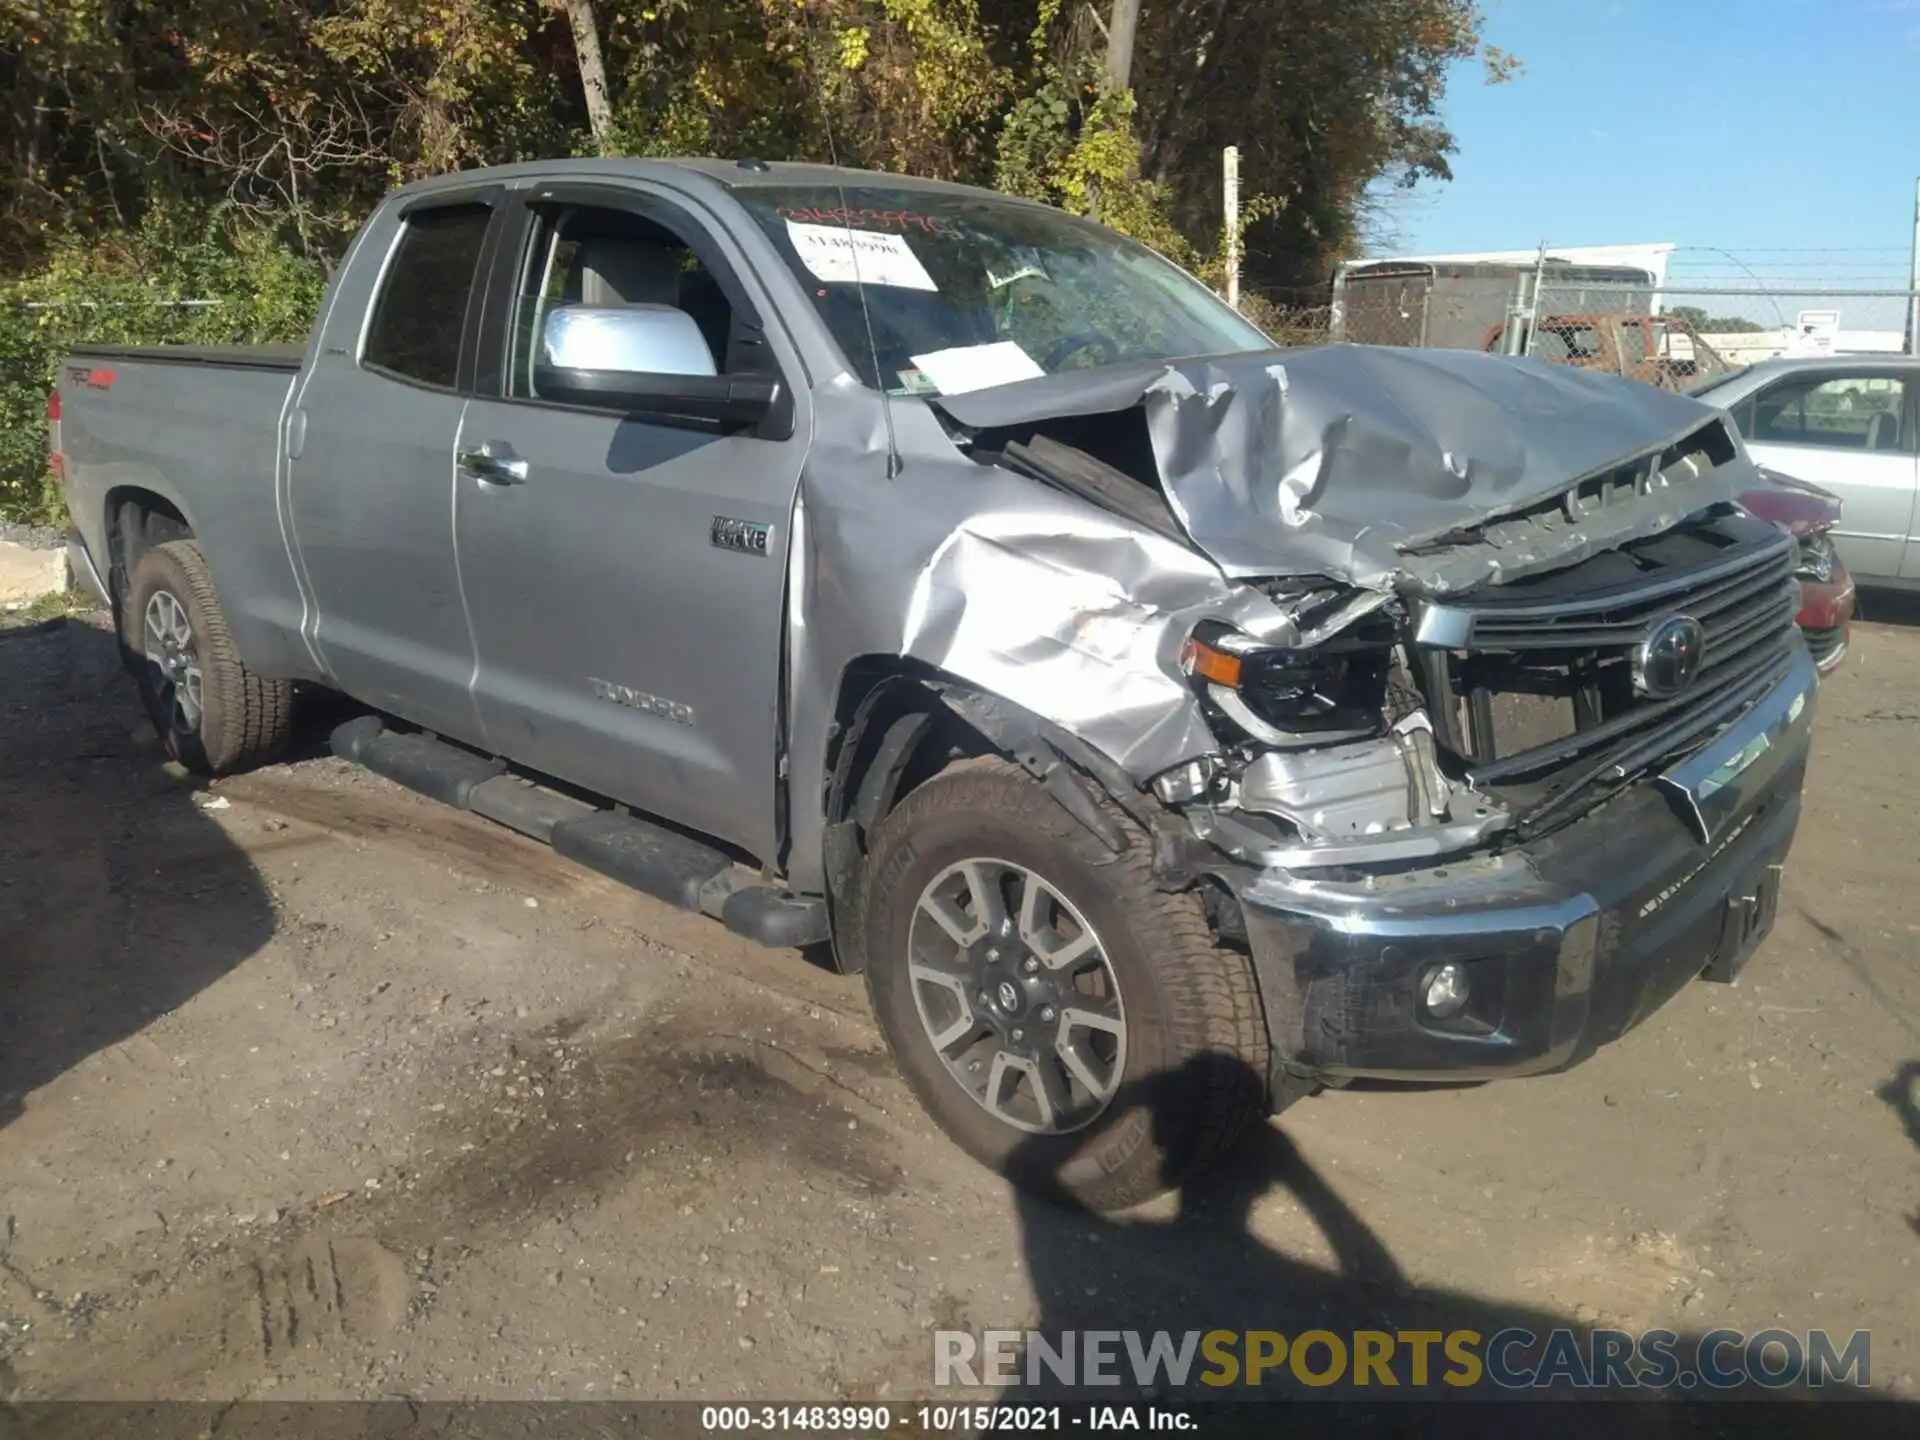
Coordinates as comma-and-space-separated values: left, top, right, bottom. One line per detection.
941, 348, 1797, 877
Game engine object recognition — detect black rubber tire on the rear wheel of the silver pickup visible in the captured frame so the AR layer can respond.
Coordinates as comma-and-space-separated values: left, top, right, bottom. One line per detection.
123, 540, 294, 776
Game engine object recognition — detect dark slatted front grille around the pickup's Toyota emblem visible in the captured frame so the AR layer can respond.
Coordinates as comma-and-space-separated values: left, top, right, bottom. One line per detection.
1409, 515, 1799, 808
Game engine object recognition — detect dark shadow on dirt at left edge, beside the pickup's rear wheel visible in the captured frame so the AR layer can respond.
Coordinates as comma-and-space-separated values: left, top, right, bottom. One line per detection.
0, 620, 275, 1127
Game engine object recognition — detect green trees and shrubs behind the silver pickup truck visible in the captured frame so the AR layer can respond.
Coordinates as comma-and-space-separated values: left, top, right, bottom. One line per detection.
0, 0, 1511, 513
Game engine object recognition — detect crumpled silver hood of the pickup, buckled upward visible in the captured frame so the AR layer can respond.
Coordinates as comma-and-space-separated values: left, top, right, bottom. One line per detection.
935, 346, 1753, 591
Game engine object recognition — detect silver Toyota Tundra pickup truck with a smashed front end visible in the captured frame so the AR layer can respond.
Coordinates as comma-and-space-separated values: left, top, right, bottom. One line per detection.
54, 159, 1814, 1206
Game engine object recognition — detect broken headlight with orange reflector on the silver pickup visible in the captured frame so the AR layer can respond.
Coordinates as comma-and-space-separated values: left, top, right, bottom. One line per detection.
1181, 622, 1392, 747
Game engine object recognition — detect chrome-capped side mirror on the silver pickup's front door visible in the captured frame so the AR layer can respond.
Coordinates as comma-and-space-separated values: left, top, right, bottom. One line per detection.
534, 305, 781, 428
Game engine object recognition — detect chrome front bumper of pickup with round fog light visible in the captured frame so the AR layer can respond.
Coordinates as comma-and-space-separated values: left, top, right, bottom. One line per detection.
1238, 647, 1818, 1079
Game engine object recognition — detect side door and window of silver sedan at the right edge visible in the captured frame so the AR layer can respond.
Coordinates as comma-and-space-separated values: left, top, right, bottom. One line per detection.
1734, 367, 1920, 580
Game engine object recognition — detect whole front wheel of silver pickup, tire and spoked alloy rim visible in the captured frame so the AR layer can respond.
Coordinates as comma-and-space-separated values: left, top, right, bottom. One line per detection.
866, 760, 1267, 1210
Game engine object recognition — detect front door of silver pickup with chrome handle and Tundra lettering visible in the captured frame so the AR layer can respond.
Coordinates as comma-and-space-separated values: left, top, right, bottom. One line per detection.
453, 188, 806, 860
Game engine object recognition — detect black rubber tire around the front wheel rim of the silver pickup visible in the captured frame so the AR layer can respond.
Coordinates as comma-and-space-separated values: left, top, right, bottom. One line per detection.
866, 758, 1267, 1210
